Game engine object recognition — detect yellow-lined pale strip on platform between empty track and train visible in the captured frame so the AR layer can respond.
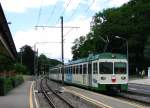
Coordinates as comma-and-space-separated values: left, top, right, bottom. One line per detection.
65, 89, 113, 108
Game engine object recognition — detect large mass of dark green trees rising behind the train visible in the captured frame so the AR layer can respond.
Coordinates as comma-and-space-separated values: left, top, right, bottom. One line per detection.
72, 0, 150, 72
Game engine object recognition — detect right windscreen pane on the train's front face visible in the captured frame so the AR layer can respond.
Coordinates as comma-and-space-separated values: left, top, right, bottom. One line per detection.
114, 62, 127, 74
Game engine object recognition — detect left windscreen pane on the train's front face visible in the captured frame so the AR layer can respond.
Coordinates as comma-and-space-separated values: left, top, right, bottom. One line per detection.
99, 62, 113, 74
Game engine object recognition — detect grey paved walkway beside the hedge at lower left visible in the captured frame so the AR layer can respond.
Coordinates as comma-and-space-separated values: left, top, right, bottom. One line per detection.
0, 81, 32, 108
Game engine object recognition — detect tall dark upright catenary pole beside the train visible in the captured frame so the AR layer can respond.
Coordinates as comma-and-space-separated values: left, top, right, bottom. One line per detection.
60, 16, 64, 85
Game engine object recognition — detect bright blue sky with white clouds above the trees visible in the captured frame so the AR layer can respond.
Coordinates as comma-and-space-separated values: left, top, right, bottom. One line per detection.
0, 0, 129, 62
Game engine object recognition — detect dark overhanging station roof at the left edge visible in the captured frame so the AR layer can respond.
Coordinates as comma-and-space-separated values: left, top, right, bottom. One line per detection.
0, 4, 17, 59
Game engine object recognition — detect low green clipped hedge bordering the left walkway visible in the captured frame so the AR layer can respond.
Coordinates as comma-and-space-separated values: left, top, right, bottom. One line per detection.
0, 76, 24, 96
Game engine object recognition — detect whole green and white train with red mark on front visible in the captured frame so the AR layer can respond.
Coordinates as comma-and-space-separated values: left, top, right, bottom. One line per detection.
49, 53, 128, 91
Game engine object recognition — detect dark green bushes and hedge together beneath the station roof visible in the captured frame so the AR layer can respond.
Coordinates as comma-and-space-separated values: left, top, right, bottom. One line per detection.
0, 55, 26, 96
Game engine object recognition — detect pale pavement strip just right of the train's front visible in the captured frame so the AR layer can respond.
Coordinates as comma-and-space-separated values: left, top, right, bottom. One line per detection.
129, 77, 150, 85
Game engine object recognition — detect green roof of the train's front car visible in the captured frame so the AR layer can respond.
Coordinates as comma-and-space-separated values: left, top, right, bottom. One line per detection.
66, 53, 127, 65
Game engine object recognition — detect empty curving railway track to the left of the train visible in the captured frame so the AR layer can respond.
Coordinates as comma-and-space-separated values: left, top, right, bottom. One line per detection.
40, 79, 75, 108
